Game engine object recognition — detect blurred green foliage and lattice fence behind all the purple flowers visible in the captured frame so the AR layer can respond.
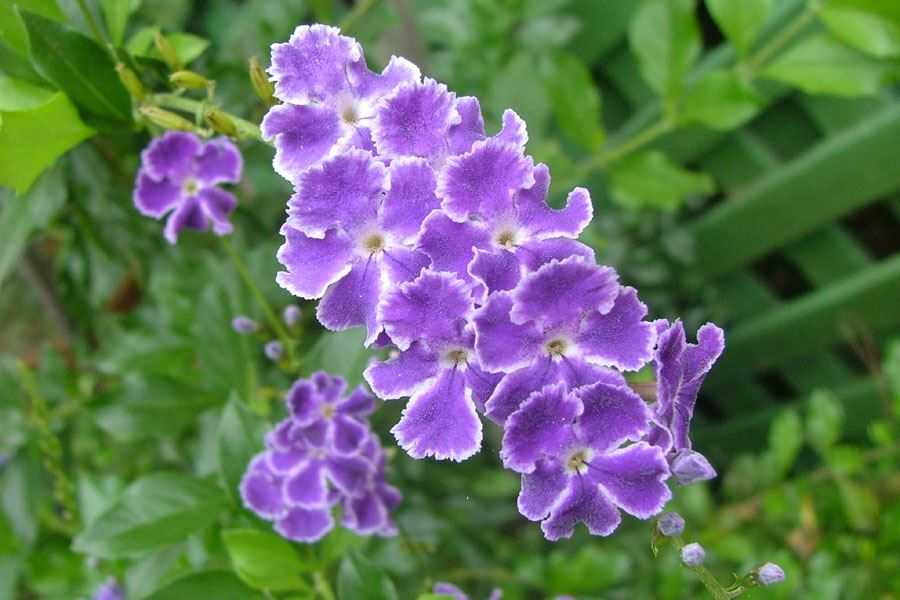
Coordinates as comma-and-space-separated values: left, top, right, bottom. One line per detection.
0, 0, 900, 600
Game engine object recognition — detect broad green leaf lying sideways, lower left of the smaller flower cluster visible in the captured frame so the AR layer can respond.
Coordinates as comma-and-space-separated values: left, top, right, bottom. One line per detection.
73, 473, 226, 558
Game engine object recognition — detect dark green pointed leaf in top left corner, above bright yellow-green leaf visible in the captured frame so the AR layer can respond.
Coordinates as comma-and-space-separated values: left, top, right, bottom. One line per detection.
21, 12, 131, 121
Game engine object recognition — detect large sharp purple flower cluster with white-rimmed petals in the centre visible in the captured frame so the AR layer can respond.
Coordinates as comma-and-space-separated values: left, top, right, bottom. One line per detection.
262, 25, 724, 539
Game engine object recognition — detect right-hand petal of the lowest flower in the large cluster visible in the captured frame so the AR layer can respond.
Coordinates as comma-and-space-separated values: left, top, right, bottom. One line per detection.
588, 442, 672, 519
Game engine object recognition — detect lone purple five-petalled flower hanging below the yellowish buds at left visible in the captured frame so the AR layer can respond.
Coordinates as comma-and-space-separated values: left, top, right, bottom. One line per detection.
134, 131, 243, 244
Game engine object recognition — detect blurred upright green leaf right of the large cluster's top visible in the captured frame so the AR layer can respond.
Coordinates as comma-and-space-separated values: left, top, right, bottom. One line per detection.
547, 54, 605, 152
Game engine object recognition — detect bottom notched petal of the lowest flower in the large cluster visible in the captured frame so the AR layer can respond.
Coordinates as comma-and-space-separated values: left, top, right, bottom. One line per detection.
541, 477, 622, 541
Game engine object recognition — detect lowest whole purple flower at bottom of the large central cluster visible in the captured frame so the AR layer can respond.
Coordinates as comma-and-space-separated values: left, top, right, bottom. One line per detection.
500, 383, 672, 540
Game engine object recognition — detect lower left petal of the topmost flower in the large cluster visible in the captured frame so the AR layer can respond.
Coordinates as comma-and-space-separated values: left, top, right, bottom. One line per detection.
260, 104, 341, 181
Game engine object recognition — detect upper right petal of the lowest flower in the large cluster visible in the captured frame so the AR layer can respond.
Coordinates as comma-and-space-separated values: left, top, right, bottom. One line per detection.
574, 383, 650, 452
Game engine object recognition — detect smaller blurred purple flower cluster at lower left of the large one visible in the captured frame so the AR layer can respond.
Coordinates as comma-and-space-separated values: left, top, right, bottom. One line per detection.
240, 372, 400, 542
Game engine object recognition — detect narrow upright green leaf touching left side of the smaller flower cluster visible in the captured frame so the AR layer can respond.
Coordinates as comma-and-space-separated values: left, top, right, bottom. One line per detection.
218, 394, 264, 504
